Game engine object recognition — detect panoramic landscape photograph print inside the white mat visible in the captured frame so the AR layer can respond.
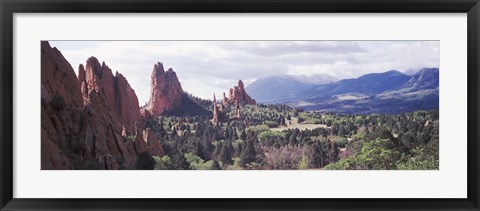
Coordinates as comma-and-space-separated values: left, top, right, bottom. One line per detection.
39, 40, 440, 170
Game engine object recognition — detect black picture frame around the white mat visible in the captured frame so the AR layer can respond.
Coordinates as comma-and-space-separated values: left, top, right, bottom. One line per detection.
0, 0, 480, 210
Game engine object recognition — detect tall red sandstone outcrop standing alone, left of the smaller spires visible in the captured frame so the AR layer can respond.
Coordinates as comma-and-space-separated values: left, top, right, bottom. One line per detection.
146, 62, 184, 116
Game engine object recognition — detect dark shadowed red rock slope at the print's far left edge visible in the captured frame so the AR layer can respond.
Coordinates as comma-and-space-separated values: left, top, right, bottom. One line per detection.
41, 42, 83, 169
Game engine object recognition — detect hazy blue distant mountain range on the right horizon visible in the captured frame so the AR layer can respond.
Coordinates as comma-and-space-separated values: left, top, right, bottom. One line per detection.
247, 68, 439, 114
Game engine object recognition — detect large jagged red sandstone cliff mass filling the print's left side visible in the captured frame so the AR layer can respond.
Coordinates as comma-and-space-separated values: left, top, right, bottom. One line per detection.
41, 42, 163, 170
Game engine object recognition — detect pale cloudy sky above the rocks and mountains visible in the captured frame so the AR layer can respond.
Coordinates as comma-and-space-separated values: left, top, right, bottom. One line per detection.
50, 41, 440, 105
